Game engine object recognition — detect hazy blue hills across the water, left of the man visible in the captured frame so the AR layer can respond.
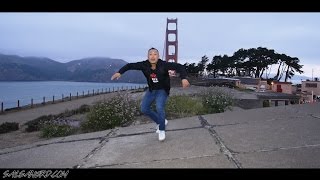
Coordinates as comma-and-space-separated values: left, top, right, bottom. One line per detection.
0, 54, 146, 83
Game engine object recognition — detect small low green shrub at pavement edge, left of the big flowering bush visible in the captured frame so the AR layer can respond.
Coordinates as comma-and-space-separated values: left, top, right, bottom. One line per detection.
41, 123, 77, 138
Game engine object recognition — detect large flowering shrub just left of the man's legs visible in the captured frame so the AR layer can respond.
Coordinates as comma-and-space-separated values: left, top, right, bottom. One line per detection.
81, 92, 139, 132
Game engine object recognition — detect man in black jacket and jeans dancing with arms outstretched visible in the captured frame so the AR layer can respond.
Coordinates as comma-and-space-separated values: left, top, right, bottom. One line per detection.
111, 48, 190, 141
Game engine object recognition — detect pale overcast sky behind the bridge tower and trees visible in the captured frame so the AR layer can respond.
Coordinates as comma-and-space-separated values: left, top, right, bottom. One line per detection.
0, 13, 320, 77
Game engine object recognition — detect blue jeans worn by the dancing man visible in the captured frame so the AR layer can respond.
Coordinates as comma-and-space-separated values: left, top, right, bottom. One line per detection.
141, 89, 168, 131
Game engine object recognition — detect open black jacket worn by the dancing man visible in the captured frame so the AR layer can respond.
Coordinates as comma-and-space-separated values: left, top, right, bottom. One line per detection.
118, 59, 187, 95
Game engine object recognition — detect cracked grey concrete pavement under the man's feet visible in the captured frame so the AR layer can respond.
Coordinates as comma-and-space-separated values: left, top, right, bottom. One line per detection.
0, 103, 320, 169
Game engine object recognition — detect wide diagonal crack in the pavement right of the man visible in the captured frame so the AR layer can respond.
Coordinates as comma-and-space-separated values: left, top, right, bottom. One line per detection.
199, 116, 242, 168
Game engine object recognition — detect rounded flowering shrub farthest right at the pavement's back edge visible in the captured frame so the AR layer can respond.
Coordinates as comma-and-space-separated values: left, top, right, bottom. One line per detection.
201, 87, 233, 114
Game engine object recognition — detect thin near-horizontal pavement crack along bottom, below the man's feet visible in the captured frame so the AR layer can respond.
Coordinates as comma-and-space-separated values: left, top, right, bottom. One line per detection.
89, 154, 219, 168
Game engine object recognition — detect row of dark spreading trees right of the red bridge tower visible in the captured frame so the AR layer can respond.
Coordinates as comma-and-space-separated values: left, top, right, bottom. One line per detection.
184, 47, 303, 82
